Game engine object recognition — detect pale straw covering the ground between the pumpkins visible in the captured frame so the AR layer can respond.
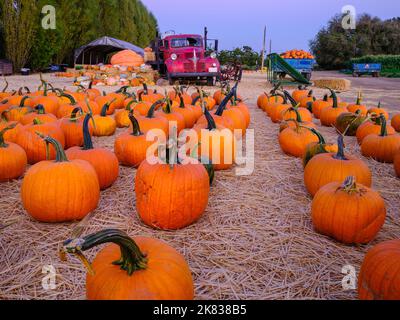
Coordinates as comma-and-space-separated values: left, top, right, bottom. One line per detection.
0, 75, 400, 300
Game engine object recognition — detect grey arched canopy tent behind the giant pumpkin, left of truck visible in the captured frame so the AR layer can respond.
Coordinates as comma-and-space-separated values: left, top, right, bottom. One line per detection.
74, 37, 144, 65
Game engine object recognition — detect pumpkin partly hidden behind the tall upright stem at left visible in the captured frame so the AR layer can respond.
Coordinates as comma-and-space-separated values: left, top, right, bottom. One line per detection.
60, 107, 93, 149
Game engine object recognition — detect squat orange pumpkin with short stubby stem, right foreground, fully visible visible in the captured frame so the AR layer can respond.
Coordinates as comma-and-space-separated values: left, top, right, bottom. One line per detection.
311, 177, 386, 244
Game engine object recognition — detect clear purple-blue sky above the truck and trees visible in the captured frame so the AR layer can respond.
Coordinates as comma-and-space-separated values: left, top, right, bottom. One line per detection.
142, 0, 400, 52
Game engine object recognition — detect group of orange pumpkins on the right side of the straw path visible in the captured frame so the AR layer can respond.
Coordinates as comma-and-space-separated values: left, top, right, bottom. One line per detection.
257, 85, 400, 300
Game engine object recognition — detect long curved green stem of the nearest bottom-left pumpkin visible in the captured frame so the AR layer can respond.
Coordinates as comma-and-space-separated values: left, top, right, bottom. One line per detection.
63, 229, 148, 276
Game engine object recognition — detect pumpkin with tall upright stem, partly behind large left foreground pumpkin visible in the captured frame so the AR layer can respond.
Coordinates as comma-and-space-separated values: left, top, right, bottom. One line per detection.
66, 114, 119, 190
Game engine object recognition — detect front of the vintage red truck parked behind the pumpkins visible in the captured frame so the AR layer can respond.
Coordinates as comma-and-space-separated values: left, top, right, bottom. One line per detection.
152, 34, 221, 85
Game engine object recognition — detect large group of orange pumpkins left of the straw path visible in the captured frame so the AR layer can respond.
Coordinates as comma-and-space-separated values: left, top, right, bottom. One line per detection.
0, 80, 250, 300
